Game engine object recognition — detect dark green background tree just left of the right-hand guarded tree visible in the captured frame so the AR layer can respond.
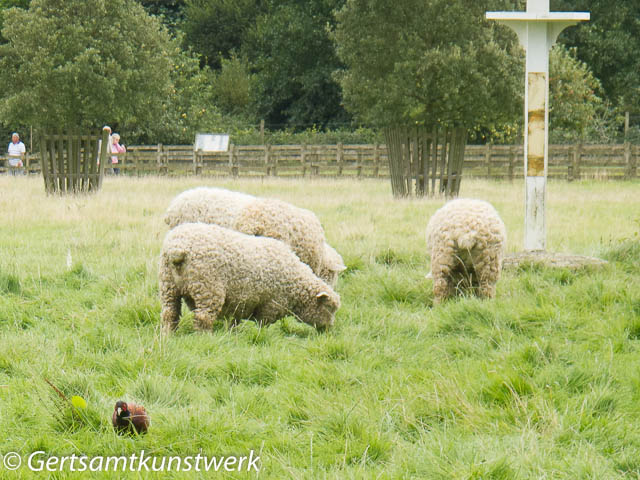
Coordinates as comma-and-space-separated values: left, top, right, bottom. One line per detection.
243, 0, 350, 127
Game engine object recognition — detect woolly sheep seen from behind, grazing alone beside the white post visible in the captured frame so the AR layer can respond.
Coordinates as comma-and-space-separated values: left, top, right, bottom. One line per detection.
427, 198, 507, 304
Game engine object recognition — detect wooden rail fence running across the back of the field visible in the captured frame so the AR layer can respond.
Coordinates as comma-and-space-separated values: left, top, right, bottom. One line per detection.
0, 143, 640, 181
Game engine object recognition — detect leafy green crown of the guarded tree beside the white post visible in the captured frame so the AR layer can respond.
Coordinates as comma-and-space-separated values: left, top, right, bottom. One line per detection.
335, 0, 523, 128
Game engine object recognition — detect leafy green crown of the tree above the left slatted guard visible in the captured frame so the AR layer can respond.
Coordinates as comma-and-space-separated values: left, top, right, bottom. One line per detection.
0, 0, 171, 137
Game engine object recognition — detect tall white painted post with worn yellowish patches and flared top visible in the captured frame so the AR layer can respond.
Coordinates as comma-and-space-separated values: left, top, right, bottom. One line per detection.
487, 0, 590, 250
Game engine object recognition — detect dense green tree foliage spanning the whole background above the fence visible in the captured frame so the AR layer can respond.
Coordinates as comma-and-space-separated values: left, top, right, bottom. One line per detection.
0, 0, 640, 142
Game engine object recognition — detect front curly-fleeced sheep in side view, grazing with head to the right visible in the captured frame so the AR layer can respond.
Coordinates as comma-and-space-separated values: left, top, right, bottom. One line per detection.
158, 223, 340, 330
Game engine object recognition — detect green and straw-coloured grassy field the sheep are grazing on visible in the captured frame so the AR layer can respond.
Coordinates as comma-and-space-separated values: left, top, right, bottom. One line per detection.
0, 177, 640, 479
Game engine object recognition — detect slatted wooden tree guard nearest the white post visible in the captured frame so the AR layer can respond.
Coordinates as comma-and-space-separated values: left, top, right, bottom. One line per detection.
384, 127, 467, 197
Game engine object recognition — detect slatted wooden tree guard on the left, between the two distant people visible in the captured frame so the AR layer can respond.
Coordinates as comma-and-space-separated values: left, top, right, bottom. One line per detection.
39, 130, 111, 193
